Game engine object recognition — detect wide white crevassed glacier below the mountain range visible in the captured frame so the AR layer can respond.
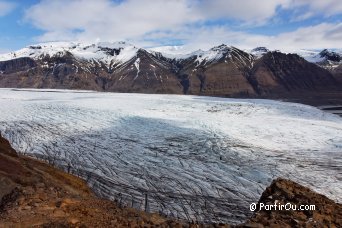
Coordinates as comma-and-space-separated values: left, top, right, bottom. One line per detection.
0, 89, 342, 223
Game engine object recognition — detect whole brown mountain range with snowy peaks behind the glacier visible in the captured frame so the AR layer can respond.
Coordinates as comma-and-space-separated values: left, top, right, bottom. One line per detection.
0, 42, 342, 101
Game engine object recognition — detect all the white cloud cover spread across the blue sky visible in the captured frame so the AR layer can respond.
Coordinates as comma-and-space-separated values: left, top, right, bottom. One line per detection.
25, 0, 342, 51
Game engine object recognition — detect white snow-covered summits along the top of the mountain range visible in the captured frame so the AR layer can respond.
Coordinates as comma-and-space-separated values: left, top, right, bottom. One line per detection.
0, 42, 342, 66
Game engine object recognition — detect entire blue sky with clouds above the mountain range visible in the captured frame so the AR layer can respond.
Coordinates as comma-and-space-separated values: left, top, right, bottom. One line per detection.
0, 0, 342, 53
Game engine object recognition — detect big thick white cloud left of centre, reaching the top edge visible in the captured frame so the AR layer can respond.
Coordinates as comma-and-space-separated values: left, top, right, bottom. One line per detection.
26, 0, 200, 40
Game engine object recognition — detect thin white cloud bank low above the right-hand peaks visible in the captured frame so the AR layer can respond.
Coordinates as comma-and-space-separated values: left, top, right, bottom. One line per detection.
152, 23, 342, 52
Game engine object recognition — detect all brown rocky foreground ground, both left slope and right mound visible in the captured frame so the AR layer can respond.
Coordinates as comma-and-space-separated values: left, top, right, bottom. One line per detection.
0, 134, 342, 227
